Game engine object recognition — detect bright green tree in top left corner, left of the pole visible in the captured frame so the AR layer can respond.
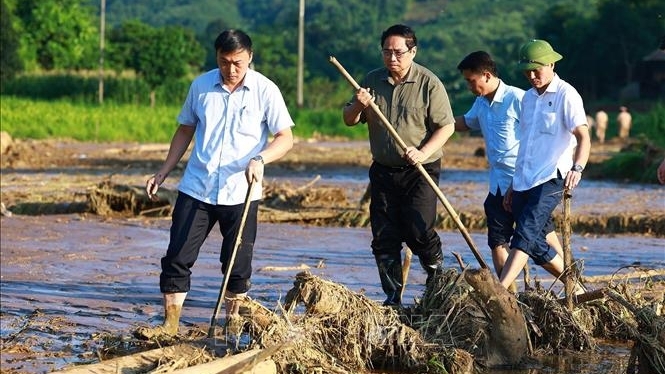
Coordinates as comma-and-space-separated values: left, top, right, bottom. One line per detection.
17, 0, 99, 70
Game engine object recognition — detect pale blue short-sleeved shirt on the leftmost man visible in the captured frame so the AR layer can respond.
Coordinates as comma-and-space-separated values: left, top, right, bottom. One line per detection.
177, 69, 294, 205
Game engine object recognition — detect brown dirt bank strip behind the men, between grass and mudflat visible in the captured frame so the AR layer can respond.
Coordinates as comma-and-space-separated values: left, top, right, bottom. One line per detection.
0, 137, 665, 236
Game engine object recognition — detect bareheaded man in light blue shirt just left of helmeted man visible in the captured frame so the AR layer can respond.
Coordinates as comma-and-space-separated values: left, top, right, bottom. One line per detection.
455, 51, 563, 282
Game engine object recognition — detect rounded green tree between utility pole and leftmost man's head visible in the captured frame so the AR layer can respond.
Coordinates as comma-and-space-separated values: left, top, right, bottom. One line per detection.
109, 21, 205, 106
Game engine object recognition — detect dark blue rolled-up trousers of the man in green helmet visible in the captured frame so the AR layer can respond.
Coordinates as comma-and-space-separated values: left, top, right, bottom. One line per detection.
510, 178, 563, 265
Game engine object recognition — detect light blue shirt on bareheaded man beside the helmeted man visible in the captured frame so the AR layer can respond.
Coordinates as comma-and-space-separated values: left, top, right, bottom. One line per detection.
464, 81, 524, 195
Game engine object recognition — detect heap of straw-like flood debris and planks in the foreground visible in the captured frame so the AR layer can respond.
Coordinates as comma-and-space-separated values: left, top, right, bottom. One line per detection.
14, 262, 665, 374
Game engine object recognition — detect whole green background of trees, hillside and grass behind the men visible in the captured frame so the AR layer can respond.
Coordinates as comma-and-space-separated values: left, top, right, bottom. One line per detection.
0, 0, 665, 181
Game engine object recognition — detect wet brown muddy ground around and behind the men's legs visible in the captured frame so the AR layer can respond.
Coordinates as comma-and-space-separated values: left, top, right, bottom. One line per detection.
0, 133, 665, 373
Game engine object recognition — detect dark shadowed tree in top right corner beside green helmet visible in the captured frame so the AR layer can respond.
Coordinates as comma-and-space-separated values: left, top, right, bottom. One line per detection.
537, 0, 665, 99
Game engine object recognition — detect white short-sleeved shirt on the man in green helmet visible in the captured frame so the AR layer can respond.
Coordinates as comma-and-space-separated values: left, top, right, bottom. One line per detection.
513, 74, 586, 191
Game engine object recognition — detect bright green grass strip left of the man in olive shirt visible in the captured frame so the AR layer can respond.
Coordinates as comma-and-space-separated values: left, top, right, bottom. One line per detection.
0, 96, 360, 143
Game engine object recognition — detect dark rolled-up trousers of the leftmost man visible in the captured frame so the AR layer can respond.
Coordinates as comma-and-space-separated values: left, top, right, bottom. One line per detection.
159, 192, 259, 293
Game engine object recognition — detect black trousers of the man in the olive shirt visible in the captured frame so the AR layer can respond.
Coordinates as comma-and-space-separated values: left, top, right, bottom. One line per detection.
369, 160, 442, 265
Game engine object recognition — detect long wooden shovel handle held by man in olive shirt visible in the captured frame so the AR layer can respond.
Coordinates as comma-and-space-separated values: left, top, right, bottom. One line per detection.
330, 56, 489, 269
